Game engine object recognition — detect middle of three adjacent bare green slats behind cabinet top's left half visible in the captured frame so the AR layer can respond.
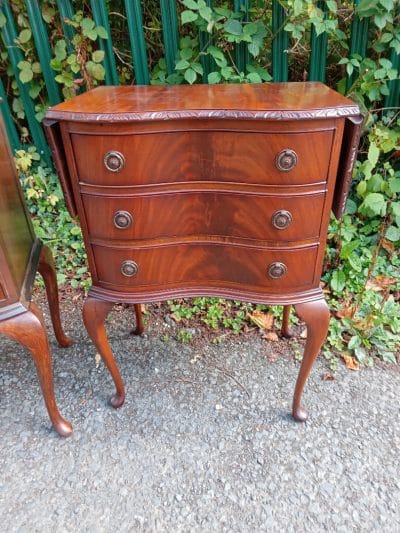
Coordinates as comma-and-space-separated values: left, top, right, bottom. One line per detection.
125, 0, 150, 85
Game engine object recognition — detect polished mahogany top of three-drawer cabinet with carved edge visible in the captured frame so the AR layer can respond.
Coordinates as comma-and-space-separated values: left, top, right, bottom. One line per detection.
46, 82, 360, 122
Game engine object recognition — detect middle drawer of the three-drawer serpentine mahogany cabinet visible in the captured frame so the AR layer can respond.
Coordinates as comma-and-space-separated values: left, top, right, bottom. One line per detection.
82, 191, 325, 242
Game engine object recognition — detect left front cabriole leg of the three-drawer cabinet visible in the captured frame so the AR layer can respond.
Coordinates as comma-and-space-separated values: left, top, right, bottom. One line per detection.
83, 296, 125, 407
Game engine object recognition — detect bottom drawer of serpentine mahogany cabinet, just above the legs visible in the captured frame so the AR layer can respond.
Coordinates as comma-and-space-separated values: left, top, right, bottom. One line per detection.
92, 242, 318, 293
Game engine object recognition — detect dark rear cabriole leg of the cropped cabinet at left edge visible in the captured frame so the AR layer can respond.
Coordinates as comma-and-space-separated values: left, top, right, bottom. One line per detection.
38, 246, 72, 348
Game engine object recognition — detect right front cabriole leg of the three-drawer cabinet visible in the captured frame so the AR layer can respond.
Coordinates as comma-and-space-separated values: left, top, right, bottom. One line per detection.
293, 298, 330, 422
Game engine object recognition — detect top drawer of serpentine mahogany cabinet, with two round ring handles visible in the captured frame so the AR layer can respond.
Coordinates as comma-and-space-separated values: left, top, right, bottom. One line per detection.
71, 130, 334, 186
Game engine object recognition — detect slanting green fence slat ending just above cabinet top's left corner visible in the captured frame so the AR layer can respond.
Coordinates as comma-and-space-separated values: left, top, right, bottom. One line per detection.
25, 0, 61, 105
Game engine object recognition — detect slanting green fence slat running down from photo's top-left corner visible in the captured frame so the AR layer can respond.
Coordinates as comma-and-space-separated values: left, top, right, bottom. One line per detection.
0, 2, 50, 162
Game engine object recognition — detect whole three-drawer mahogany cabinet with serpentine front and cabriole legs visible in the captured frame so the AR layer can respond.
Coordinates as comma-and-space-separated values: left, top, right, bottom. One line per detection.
45, 83, 361, 420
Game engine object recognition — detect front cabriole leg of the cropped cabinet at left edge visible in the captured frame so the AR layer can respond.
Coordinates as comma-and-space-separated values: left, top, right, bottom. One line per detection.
0, 303, 72, 437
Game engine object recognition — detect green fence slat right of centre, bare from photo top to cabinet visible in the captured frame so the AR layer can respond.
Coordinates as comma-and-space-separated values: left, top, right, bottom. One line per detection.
272, 0, 289, 81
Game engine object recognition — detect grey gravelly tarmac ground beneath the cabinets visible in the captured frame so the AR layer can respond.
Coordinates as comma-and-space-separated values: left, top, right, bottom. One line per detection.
0, 294, 400, 533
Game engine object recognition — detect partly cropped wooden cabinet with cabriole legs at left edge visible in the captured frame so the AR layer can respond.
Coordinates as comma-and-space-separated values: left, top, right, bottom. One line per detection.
0, 113, 72, 437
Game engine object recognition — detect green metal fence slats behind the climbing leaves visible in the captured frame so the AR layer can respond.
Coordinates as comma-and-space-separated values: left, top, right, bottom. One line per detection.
0, 0, 400, 158
